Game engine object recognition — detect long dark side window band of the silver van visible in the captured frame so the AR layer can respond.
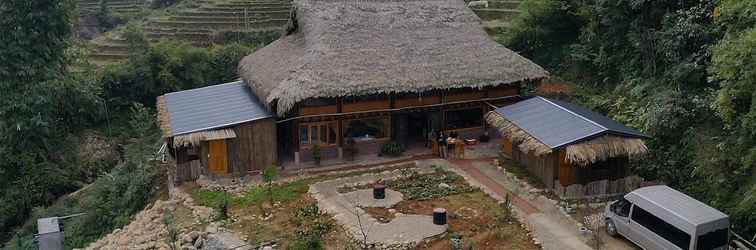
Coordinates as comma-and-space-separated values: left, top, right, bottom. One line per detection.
631, 206, 690, 250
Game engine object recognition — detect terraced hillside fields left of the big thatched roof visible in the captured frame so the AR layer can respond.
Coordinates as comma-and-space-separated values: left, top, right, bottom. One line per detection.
85, 0, 291, 65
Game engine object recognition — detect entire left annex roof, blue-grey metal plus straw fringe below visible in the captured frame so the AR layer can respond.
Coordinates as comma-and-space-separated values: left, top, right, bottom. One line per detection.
157, 81, 273, 146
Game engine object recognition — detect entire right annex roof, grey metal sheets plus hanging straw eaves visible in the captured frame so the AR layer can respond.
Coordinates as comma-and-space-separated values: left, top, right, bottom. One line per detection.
486, 97, 648, 166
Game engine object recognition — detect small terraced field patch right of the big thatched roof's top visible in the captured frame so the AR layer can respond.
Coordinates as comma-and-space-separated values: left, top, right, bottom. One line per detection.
472, 0, 520, 35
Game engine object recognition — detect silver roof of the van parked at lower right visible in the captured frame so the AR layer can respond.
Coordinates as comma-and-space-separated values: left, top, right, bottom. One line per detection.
625, 185, 728, 230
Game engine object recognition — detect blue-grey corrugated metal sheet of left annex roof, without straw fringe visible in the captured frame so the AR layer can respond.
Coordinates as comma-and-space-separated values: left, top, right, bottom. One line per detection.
165, 81, 273, 136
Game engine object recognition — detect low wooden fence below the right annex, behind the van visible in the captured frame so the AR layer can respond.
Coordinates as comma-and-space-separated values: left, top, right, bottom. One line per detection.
554, 176, 643, 200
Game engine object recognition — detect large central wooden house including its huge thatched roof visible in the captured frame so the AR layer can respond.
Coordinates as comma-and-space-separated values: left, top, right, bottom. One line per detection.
239, 0, 548, 162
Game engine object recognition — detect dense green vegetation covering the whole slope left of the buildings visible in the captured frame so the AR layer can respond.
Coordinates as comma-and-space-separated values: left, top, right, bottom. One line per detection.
0, 0, 253, 246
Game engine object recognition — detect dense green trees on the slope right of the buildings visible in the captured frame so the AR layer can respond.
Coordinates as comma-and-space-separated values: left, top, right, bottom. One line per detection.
500, 0, 756, 236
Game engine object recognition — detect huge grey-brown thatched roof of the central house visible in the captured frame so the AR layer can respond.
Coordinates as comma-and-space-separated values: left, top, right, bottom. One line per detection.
239, 0, 548, 115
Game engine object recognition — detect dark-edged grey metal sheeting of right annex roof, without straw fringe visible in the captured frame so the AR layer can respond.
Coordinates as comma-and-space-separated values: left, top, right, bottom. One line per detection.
496, 96, 648, 148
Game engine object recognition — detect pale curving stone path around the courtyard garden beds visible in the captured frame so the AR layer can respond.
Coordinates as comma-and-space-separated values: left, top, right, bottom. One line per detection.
310, 164, 447, 247
